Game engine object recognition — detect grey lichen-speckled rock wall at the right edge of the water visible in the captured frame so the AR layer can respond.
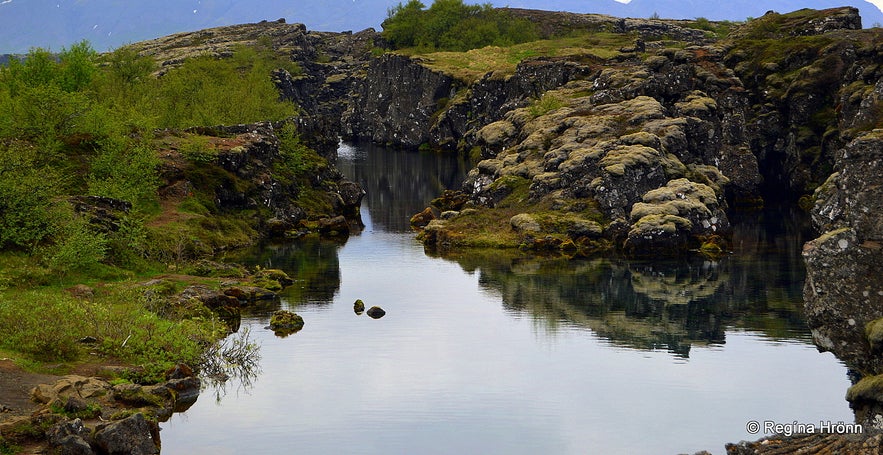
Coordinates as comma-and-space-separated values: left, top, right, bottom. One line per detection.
803, 130, 883, 429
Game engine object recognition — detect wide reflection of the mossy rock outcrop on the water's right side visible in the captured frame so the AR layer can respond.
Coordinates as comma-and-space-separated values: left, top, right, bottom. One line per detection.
438, 208, 809, 357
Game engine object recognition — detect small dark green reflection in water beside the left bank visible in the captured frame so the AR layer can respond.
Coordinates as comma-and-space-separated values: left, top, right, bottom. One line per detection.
233, 238, 346, 305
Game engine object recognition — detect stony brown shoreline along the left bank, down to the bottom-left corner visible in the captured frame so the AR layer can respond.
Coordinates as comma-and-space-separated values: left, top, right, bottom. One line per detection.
0, 261, 303, 455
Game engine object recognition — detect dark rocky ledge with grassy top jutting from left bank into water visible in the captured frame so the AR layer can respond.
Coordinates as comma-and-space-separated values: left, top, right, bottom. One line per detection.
160, 122, 365, 242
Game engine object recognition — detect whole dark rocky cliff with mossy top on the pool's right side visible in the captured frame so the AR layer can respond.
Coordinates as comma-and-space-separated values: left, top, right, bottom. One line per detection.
342, 8, 880, 255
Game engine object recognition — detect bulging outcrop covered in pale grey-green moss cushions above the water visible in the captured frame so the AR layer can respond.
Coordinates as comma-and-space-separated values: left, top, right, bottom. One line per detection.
408, 44, 744, 255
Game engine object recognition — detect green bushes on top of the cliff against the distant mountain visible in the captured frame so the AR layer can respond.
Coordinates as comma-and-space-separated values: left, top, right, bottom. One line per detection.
383, 0, 539, 51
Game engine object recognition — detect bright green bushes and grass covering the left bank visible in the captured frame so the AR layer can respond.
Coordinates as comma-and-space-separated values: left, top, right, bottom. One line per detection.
0, 38, 316, 374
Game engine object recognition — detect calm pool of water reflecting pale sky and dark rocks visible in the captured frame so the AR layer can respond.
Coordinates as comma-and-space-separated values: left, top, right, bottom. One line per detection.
161, 142, 853, 454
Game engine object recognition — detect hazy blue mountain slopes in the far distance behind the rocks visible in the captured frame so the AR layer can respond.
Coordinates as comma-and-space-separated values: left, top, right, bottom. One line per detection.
0, 0, 883, 53
